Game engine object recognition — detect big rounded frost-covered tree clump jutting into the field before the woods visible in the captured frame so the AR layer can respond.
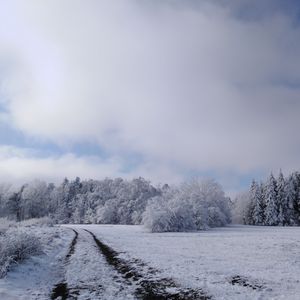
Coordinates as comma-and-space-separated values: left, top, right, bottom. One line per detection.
143, 179, 231, 231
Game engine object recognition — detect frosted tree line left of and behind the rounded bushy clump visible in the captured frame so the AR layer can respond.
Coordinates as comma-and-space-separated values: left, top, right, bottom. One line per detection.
0, 177, 161, 224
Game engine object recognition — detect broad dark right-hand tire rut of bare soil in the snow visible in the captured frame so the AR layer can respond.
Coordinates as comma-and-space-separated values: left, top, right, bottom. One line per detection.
84, 229, 211, 300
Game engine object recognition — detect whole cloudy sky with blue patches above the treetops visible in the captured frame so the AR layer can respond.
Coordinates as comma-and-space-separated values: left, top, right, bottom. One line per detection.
0, 0, 300, 194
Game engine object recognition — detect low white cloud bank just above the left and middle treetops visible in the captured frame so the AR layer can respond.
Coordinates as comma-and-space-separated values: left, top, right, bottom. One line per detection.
0, 145, 183, 184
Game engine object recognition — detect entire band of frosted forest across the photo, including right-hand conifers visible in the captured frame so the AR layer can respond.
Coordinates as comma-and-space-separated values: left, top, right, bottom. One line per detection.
0, 172, 300, 232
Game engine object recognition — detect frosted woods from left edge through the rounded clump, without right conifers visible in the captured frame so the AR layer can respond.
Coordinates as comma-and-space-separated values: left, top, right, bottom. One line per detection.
0, 177, 231, 231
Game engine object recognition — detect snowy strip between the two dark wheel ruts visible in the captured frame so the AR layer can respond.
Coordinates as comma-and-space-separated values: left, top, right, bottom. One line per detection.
65, 230, 134, 300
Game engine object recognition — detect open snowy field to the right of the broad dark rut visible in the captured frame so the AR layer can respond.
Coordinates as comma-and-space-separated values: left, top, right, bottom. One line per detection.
72, 225, 300, 300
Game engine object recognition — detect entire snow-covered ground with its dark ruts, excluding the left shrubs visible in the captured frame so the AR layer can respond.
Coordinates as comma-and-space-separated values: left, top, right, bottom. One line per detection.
0, 225, 300, 300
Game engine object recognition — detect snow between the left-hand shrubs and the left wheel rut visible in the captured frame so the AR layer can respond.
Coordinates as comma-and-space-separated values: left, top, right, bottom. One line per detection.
0, 227, 72, 300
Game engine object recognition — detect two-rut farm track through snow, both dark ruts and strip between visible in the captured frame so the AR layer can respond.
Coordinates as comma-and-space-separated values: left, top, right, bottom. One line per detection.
52, 229, 210, 300
